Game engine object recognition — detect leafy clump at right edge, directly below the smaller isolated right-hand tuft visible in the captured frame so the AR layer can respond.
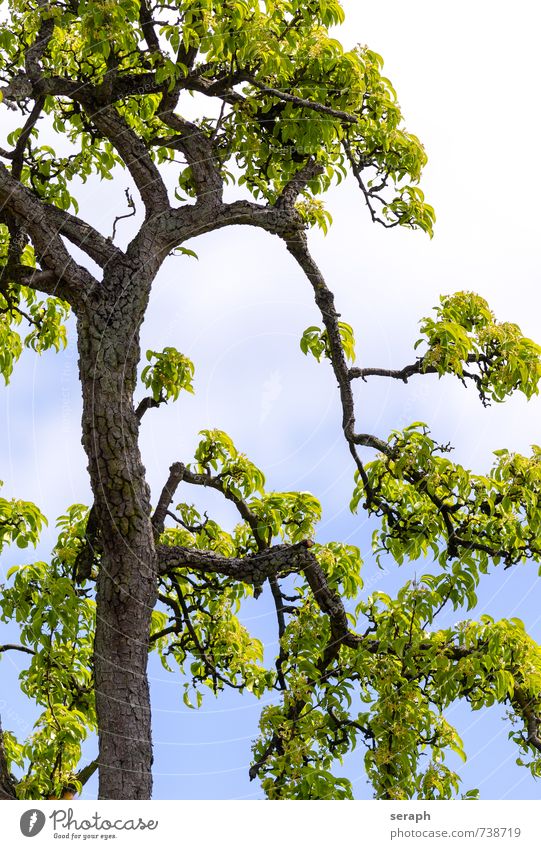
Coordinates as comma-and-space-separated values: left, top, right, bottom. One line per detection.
351, 423, 541, 572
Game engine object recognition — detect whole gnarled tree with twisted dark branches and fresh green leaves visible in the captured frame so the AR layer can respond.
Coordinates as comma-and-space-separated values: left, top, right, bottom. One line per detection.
0, 0, 541, 798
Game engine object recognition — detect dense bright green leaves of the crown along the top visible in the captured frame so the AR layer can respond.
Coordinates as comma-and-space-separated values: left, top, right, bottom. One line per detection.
0, 0, 434, 232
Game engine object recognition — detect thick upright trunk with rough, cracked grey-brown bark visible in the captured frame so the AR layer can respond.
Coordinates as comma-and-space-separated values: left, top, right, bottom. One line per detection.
78, 267, 157, 799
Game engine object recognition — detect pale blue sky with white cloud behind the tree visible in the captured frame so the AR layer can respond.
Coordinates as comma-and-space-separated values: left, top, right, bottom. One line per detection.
0, 0, 541, 799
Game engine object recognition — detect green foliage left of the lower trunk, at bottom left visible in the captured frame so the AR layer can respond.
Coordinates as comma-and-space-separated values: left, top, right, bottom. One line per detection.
0, 505, 96, 799
